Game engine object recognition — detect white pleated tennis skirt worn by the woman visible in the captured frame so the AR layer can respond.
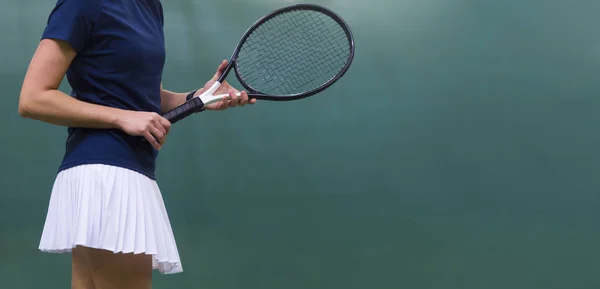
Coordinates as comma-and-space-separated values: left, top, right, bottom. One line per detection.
39, 164, 183, 274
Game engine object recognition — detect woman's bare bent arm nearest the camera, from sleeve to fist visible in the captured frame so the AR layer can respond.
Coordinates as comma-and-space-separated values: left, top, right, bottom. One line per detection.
19, 39, 171, 149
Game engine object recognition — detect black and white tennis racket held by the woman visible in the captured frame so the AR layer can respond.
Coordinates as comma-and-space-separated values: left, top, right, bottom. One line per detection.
163, 4, 354, 123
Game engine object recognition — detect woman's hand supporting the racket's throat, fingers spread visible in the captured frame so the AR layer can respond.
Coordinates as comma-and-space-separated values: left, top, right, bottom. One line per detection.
196, 60, 256, 110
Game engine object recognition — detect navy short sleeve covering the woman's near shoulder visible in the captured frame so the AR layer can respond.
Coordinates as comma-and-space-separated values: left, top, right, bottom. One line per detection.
42, 0, 100, 53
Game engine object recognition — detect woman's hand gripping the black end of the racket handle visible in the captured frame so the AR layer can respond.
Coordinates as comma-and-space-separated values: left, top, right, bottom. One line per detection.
117, 111, 171, 150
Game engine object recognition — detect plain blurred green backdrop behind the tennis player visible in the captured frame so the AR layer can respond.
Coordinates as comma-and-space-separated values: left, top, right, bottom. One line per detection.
0, 0, 600, 289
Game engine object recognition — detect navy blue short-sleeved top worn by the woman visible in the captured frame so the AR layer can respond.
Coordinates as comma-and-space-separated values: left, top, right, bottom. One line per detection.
42, 0, 165, 179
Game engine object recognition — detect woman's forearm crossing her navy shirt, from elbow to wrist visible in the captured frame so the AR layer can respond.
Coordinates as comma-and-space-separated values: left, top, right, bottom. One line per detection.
19, 90, 124, 128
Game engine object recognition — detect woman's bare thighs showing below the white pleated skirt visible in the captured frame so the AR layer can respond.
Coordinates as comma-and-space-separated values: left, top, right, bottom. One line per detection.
73, 247, 152, 289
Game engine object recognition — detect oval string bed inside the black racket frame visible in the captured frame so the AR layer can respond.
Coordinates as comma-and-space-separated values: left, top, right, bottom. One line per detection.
237, 10, 350, 95
